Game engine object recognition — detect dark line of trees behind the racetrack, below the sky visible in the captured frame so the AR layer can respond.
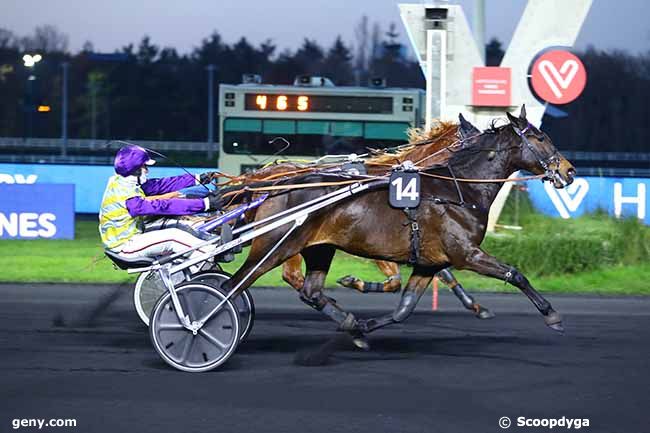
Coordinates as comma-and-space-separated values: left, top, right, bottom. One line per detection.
0, 22, 650, 152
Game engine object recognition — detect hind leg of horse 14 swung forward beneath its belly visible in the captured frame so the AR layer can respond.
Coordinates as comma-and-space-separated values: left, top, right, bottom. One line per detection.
300, 245, 369, 350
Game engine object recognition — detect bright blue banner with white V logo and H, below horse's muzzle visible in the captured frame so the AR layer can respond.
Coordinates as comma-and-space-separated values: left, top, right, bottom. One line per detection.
528, 177, 650, 225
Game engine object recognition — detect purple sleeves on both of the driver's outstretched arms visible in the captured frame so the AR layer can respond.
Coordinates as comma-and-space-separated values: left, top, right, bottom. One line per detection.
126, 174, 205, 217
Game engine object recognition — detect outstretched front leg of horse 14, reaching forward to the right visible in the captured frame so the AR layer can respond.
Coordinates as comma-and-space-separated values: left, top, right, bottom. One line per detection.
454, 247, 564, 332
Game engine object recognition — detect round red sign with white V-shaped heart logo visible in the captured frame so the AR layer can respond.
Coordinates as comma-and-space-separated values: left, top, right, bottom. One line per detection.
531, 50, 587, 104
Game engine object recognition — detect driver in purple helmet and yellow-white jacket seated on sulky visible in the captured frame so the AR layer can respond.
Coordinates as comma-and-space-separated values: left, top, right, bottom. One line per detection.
99, 145, 222, 258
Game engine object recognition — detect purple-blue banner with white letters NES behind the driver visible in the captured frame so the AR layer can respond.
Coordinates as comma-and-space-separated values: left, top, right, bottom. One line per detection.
0, 183, 74, 239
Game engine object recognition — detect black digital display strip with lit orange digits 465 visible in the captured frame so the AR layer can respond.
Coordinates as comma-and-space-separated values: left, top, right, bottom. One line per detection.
244, 93, 393, 114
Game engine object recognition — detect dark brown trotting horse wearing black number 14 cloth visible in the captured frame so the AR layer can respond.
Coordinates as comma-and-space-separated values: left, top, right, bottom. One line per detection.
226, 107, 575, 348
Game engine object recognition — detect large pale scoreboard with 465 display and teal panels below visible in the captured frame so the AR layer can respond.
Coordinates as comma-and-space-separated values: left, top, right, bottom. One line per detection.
219, 79, 424, 175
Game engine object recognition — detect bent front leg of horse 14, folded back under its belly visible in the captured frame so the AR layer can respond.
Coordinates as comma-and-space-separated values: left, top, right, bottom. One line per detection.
359, 266, 435, 332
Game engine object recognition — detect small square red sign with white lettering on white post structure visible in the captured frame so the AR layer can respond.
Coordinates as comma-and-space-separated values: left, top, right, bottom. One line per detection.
472, 66, 510, 107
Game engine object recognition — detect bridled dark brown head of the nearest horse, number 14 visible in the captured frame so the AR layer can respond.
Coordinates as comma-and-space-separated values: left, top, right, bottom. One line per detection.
506, 106, 576, 188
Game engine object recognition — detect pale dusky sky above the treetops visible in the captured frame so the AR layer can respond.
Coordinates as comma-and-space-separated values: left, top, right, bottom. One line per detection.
5, 0, 650, 53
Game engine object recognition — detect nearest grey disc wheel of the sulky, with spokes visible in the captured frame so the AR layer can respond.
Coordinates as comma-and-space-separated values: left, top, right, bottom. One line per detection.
149, 282, 239, 373
